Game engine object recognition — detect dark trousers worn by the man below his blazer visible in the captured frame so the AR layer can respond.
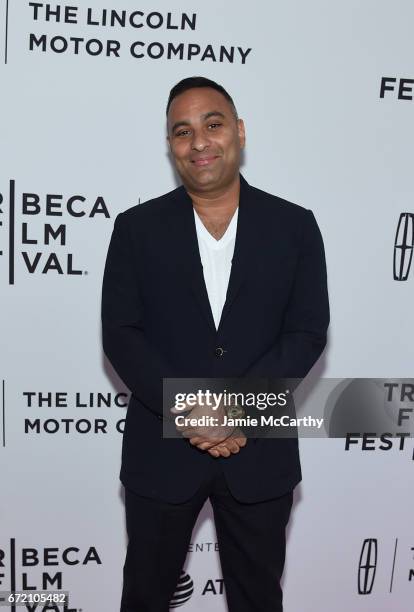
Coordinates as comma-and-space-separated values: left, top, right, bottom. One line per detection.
121, 461, 293, 612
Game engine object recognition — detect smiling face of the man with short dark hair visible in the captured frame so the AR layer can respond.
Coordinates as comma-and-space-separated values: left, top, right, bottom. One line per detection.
167, 87, 245, 195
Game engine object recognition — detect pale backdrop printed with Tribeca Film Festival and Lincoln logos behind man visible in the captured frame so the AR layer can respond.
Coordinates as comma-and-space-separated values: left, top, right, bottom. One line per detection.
0, 0, 414, 612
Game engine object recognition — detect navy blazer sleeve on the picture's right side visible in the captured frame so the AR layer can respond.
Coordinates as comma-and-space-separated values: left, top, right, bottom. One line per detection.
244, 210, 329, 379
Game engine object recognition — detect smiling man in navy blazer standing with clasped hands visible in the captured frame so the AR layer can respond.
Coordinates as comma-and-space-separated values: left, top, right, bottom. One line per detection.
102, 77, 329, 612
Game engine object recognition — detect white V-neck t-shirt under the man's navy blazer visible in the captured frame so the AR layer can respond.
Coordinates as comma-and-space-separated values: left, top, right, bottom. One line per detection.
194, 208, 239, 329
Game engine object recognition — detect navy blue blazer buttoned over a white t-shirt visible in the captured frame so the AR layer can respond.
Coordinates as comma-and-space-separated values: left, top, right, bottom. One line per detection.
102, 176, 329, 503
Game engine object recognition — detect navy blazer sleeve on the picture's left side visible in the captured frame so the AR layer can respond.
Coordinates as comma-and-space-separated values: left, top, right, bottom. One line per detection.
101, 213, 174, 416
